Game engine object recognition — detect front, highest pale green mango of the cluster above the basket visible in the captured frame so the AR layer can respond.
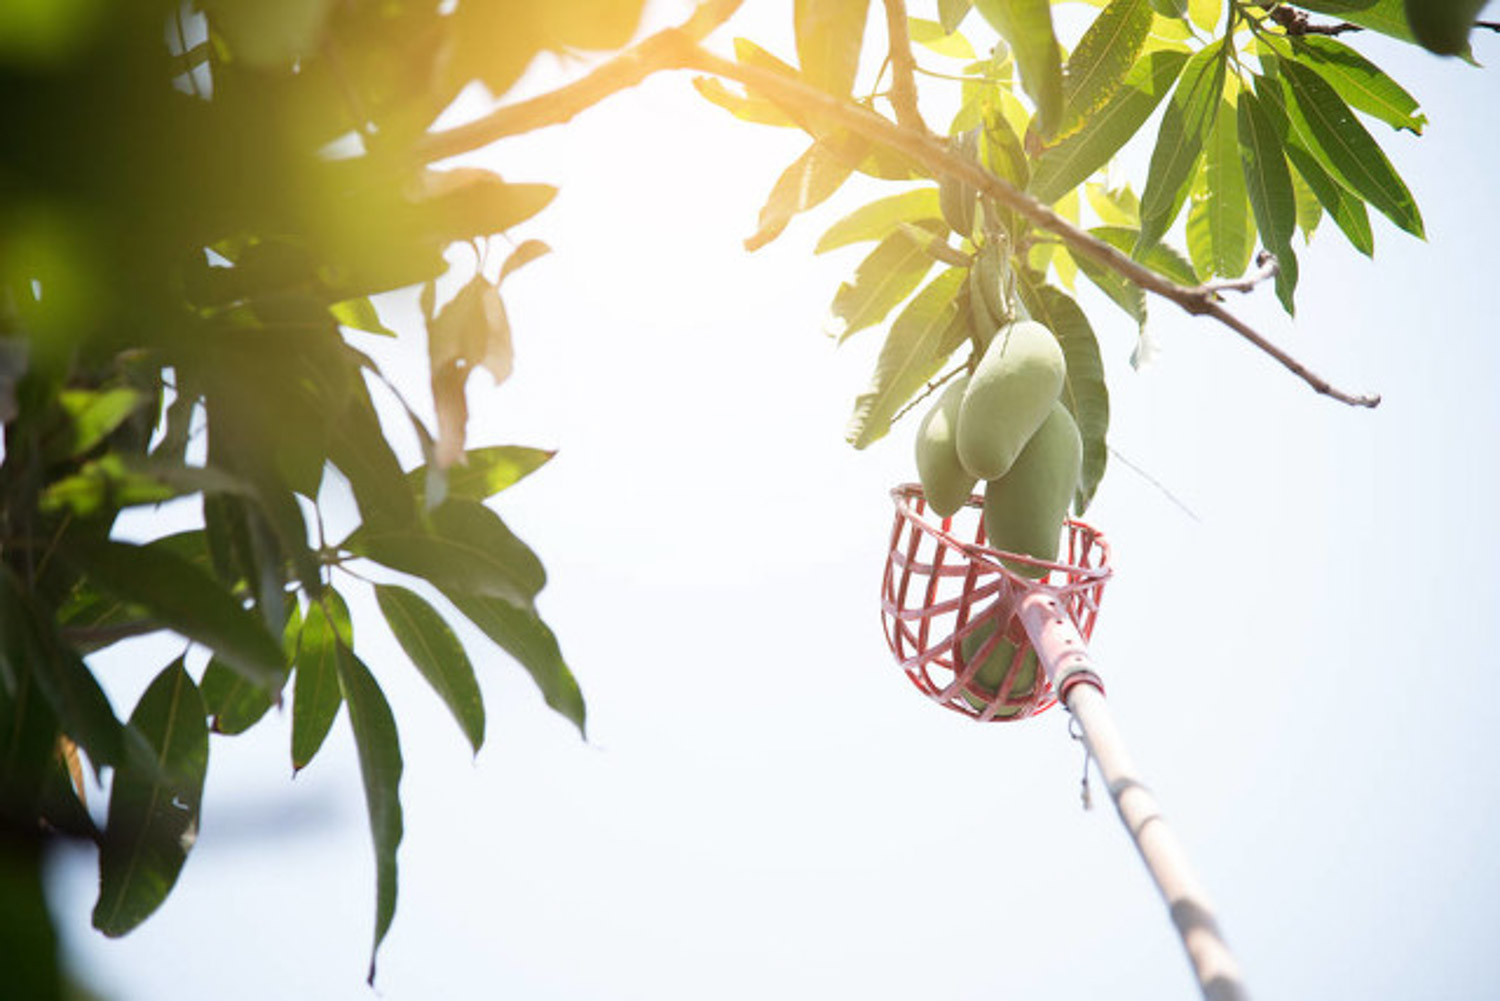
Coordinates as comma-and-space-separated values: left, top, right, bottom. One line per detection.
959, 320, 1067, 480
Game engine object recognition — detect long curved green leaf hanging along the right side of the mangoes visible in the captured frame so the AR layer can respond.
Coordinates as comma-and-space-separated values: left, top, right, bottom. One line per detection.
1017, 273, 1110, 515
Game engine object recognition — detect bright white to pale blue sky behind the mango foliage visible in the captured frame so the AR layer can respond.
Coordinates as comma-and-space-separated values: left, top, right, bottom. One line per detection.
43, 0, 1500, 1001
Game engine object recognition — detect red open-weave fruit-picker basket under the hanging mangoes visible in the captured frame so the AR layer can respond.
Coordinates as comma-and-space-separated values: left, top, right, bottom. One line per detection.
881, 483, 1110, 722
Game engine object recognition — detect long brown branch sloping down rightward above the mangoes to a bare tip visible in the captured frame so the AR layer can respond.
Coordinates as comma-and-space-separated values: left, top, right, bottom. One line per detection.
674, 45, 1380, 407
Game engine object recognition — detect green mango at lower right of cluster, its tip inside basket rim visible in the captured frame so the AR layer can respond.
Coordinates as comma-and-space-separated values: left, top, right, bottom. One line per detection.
984, 401, 1083, 578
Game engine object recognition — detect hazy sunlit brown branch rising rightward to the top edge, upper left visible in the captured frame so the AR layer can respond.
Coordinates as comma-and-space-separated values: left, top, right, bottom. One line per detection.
414, 0, 741, 164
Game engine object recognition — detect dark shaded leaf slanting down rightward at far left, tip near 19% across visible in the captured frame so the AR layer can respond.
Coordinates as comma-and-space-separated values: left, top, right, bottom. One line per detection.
65, 540, 285, 687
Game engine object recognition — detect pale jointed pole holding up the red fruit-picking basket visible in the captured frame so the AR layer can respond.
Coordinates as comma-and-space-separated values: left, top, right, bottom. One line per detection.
1019, 587, 1250, 1001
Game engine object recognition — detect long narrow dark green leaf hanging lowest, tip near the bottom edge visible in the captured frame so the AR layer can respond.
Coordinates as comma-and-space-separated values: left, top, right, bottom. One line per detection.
338, 644, 402, 986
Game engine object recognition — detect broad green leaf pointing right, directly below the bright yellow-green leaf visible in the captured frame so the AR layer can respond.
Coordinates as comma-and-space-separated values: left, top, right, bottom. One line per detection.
344, 498, 546, 609
